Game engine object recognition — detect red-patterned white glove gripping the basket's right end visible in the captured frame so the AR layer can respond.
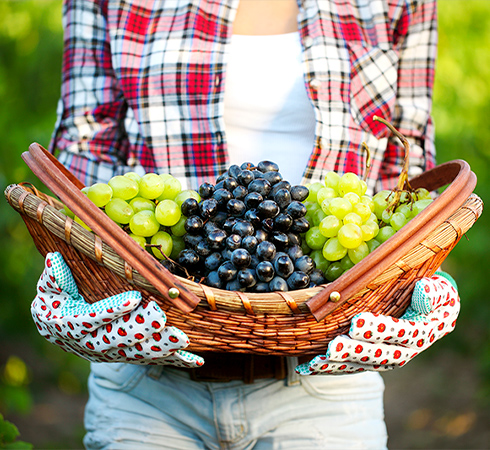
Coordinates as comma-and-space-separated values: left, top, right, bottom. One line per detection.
296, 272, 460, 375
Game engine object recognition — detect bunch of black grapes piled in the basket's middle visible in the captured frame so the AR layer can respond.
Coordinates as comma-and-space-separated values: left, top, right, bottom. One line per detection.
178, 161, 326, 292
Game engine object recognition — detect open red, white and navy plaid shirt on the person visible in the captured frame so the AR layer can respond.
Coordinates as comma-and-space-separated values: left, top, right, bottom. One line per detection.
50, 0, 437, 190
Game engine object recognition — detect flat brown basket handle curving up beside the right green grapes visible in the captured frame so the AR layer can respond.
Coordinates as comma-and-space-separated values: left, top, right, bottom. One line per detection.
306, 159, 476, 321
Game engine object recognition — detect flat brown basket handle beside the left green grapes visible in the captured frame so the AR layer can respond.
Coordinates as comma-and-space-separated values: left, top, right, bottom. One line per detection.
22, 143, 200, 313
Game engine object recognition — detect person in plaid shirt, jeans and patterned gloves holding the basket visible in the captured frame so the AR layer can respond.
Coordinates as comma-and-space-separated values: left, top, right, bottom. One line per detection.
32, 0, 459, 449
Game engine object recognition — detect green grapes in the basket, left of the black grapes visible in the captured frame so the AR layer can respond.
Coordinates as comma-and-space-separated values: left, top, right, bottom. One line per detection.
64, 172, 201, 260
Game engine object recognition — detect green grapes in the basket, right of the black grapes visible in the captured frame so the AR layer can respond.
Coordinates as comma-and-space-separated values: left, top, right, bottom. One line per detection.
303, 172, 432, 281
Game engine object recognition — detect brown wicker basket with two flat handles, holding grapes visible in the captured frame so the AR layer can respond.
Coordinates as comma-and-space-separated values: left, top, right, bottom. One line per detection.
5, 144, 483, 356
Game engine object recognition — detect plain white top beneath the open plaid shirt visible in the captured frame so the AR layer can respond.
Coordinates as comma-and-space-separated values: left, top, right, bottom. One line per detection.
224, 32, 315, 184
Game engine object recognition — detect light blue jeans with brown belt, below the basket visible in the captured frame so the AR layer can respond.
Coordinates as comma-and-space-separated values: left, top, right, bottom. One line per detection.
84, 360, 387, 450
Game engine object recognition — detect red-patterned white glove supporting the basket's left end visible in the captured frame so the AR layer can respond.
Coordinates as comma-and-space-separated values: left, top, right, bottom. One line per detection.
31, 252, 204, 367
